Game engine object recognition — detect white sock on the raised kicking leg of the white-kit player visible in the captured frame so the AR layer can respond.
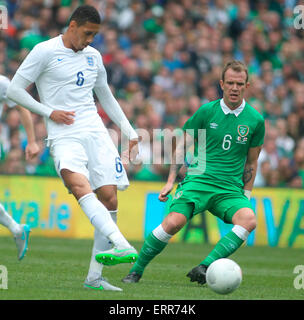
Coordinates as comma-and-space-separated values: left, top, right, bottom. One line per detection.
78, 193, 131, 248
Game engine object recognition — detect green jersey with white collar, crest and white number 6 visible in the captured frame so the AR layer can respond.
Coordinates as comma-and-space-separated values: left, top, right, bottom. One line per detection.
182, 99, 265, 191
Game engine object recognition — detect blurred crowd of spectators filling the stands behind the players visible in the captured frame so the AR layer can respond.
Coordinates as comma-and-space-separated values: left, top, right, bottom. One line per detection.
0, 0, 304, 188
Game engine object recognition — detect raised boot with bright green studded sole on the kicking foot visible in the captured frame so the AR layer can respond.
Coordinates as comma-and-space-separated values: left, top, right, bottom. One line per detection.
95, 247, 138, 266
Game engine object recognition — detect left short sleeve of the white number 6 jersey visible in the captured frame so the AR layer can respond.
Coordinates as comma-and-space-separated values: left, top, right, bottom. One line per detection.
17, 42, 50, 82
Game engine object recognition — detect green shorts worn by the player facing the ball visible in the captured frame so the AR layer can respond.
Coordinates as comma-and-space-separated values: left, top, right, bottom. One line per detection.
169, 183, 253, 223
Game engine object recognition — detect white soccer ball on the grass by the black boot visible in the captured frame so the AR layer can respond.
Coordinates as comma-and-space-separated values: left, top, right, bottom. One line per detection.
206, 258, 242, 294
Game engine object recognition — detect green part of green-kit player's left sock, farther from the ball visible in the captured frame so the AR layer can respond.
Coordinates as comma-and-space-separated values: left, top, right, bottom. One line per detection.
130, 232, 167, 275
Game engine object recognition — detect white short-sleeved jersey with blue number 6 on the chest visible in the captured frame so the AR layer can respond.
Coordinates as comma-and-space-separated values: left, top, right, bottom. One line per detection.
17, 35, 107, 139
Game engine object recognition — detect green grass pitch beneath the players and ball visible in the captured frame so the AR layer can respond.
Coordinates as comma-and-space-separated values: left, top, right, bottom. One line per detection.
0, 237, 304, 300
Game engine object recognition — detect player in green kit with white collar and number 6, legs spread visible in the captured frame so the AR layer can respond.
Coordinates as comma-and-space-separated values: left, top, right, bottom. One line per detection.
122, 61, 265, 284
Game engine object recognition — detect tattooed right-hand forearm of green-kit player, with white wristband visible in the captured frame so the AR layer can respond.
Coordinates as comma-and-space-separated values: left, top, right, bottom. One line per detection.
243, 146, 262, 198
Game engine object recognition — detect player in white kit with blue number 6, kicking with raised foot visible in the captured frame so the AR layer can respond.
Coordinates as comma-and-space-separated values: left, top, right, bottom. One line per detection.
8, 5, 138, 291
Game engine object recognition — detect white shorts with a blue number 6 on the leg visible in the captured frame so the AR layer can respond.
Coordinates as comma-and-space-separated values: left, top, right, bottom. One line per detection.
50, 132, 129, 190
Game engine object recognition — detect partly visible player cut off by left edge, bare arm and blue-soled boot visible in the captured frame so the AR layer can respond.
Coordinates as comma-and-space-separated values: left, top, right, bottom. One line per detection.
0, 75, 39, 260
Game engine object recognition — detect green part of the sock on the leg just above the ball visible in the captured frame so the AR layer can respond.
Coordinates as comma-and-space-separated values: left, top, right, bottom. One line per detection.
200, 231, 244, 267
